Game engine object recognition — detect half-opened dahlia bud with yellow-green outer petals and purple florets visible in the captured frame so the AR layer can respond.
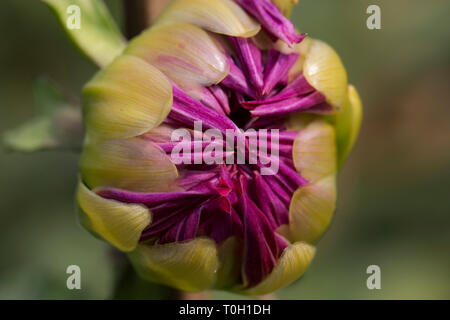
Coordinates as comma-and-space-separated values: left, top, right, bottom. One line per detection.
69, 0, 361, 295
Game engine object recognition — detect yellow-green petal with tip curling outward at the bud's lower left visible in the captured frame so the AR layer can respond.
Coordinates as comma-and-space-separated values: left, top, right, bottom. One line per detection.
77, 182, 151, 252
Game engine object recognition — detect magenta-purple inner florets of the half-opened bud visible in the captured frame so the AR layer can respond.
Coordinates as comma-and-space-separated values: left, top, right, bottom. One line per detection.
97, 0, 329, 287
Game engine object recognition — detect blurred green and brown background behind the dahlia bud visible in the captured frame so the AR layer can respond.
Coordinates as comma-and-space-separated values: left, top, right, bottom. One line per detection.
0, 0, 450, 299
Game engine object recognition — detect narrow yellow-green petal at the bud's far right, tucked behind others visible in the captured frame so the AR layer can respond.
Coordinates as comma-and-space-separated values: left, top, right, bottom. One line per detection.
335, 85, 362, 167
